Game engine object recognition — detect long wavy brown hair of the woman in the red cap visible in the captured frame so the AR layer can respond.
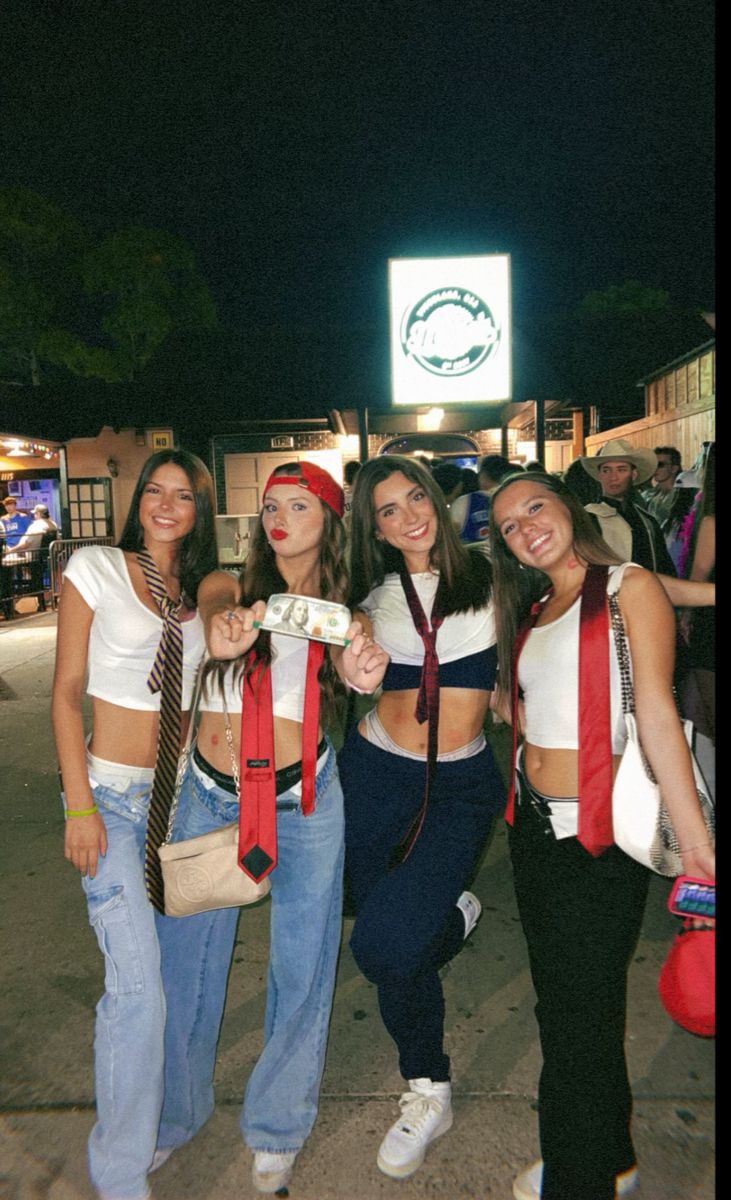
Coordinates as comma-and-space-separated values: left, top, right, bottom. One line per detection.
215, 462, 348, 718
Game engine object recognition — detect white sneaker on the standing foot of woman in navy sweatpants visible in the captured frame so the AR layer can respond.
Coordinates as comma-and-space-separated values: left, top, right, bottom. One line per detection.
376, 1079, 453, 1180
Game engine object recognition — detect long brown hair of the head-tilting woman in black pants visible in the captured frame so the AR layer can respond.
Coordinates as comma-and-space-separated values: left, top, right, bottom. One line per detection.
490, 470, 622, 700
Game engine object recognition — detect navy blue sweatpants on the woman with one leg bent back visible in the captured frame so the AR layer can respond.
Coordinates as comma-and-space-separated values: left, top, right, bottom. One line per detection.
338, 730, 504, 1081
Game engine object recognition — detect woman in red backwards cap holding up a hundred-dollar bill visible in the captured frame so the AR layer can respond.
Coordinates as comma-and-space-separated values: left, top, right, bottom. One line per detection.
154, 462, 388, 1192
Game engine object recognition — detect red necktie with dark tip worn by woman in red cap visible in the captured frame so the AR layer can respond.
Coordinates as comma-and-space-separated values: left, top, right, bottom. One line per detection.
239, 641, 325, 883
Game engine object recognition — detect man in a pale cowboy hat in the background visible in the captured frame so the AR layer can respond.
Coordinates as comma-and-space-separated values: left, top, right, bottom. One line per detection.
580, 438, 676, 575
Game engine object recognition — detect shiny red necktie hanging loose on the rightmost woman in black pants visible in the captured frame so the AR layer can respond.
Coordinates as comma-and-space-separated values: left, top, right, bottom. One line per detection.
505, 566, 615, 857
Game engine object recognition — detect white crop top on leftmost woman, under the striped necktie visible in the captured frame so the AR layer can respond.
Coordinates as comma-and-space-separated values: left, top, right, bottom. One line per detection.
65, 546, 205, 712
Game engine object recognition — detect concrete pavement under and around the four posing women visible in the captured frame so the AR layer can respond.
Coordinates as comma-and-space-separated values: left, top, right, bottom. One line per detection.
0, 613, 715, 1200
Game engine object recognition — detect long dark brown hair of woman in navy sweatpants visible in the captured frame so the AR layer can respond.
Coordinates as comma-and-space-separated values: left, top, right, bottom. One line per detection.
350, 454, 492, 616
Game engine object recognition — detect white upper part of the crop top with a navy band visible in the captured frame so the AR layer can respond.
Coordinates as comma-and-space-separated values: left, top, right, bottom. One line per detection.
354, 571, 496, 667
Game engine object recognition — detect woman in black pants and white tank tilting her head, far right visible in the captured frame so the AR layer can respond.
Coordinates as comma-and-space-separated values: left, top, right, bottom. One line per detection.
491, 473, 715, 1200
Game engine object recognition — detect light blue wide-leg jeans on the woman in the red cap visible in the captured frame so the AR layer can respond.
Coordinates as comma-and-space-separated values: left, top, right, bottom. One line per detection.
156, 746, 343, 1152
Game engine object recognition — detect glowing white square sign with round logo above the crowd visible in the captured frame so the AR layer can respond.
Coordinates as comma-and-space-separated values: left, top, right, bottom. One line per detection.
389, 254, 511, 406
